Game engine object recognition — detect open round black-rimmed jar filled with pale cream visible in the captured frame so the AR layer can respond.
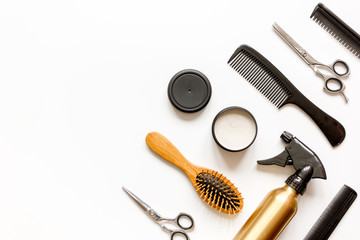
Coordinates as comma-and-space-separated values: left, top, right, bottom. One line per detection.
211, 106, 257, 152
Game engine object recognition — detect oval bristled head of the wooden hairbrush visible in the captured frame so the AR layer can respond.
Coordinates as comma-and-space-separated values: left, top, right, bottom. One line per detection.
195, 171, 244, 214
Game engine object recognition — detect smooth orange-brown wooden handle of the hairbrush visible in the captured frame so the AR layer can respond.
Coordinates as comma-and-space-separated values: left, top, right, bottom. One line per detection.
145, 132, 197, 176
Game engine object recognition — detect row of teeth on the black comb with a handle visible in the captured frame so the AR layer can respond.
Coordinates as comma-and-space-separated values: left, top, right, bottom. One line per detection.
229, 49, 291, 108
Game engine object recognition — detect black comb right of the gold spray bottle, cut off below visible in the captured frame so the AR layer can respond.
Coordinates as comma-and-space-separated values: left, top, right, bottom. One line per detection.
304, 185, 357, 240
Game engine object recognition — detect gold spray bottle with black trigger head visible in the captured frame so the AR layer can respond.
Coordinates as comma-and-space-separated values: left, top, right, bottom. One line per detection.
234, 132, 326, 240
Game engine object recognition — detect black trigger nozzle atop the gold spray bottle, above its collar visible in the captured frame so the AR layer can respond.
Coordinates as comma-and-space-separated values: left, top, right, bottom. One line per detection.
257, 131, 326, 179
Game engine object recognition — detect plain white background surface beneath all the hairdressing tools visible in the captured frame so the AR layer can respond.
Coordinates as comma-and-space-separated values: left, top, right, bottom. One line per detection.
0, 0, 360, 240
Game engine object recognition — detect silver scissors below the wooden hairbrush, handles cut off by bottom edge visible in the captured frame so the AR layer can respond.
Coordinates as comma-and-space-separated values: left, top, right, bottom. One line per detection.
123, 187, 194, 240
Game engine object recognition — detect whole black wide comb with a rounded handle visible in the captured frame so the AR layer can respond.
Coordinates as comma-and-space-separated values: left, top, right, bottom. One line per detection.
228, 45, 346, 147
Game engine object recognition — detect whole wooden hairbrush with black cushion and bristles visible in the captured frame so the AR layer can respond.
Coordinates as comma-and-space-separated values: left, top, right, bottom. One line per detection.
146, 132, 244, 214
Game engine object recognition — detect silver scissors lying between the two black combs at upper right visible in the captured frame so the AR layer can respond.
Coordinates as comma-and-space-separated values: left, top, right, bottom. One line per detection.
273, 23, 350, 102
